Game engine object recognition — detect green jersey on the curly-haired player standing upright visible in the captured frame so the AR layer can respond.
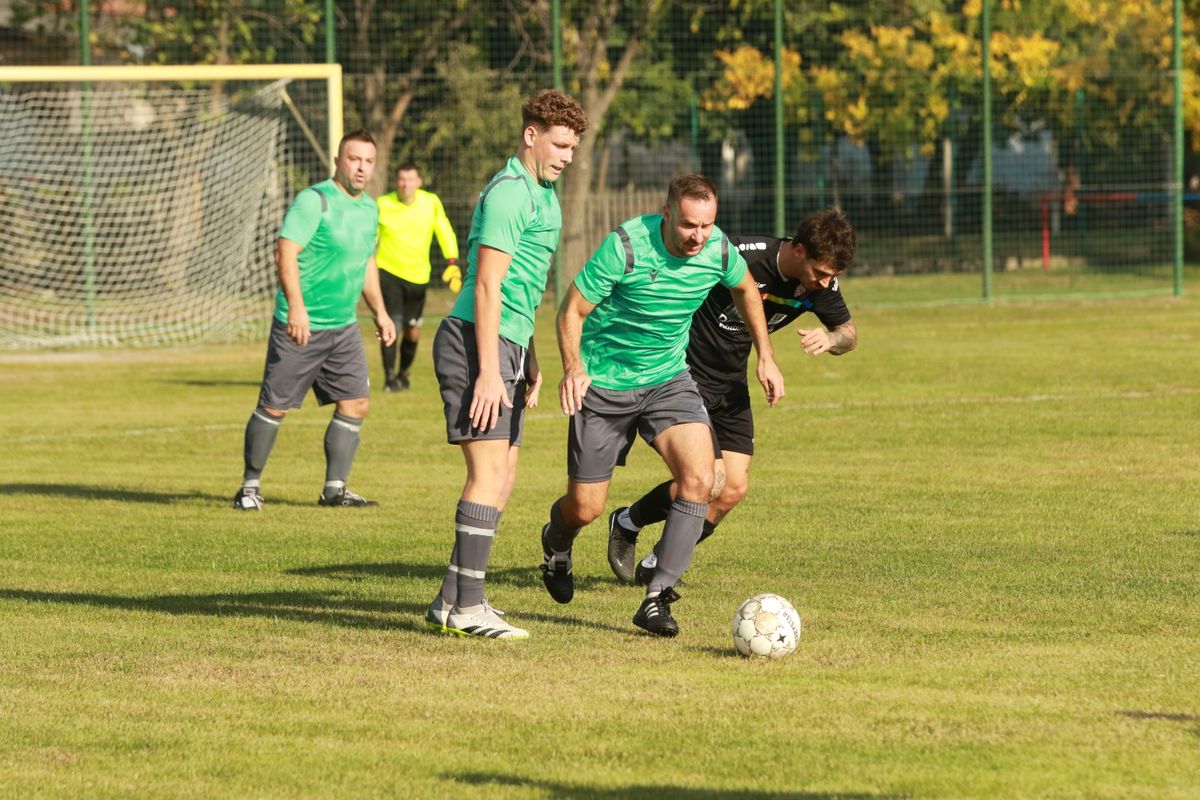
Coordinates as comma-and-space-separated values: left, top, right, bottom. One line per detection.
450, 156, 563, 347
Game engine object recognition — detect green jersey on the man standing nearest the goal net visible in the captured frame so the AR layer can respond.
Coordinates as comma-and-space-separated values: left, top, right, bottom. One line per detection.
275, 178, 379, 331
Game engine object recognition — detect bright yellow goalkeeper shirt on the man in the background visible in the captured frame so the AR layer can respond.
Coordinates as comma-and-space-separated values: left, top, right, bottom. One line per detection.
376, 190, 458, 283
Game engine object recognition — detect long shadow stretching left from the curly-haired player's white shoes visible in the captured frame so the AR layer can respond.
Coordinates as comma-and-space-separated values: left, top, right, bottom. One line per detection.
0, 589, 425, 631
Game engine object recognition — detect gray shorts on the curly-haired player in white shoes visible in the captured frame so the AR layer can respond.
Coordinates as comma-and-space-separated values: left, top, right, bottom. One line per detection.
433, 317, 527, 446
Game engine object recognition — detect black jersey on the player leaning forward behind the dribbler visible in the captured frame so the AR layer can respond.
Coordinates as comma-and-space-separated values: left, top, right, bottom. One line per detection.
688, 236, 850, 384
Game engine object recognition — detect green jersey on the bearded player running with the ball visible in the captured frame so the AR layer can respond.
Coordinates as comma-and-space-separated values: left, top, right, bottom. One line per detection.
575, 213, 746, 390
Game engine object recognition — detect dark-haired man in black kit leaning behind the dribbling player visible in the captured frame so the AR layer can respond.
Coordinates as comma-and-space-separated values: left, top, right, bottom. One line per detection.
608, 209, 858, 585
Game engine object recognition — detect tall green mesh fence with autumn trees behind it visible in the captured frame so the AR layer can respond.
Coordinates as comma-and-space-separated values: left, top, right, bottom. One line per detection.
0, 0, 1200, 303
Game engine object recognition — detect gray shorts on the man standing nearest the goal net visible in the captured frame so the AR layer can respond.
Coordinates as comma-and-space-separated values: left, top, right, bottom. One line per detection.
258, 319, 371, 409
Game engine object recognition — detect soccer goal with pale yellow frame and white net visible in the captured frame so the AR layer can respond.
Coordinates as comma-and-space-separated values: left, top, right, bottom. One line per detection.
0, 65, 342, 350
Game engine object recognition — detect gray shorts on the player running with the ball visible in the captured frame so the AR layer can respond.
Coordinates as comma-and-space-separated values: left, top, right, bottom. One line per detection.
566, 372, 712, 483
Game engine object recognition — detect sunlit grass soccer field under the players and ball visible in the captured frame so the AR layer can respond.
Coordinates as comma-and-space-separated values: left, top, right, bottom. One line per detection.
0, 289, 1200, 800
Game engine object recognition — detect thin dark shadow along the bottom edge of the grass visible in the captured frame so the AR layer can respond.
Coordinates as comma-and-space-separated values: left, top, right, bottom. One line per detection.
443, 772, 908, 800
